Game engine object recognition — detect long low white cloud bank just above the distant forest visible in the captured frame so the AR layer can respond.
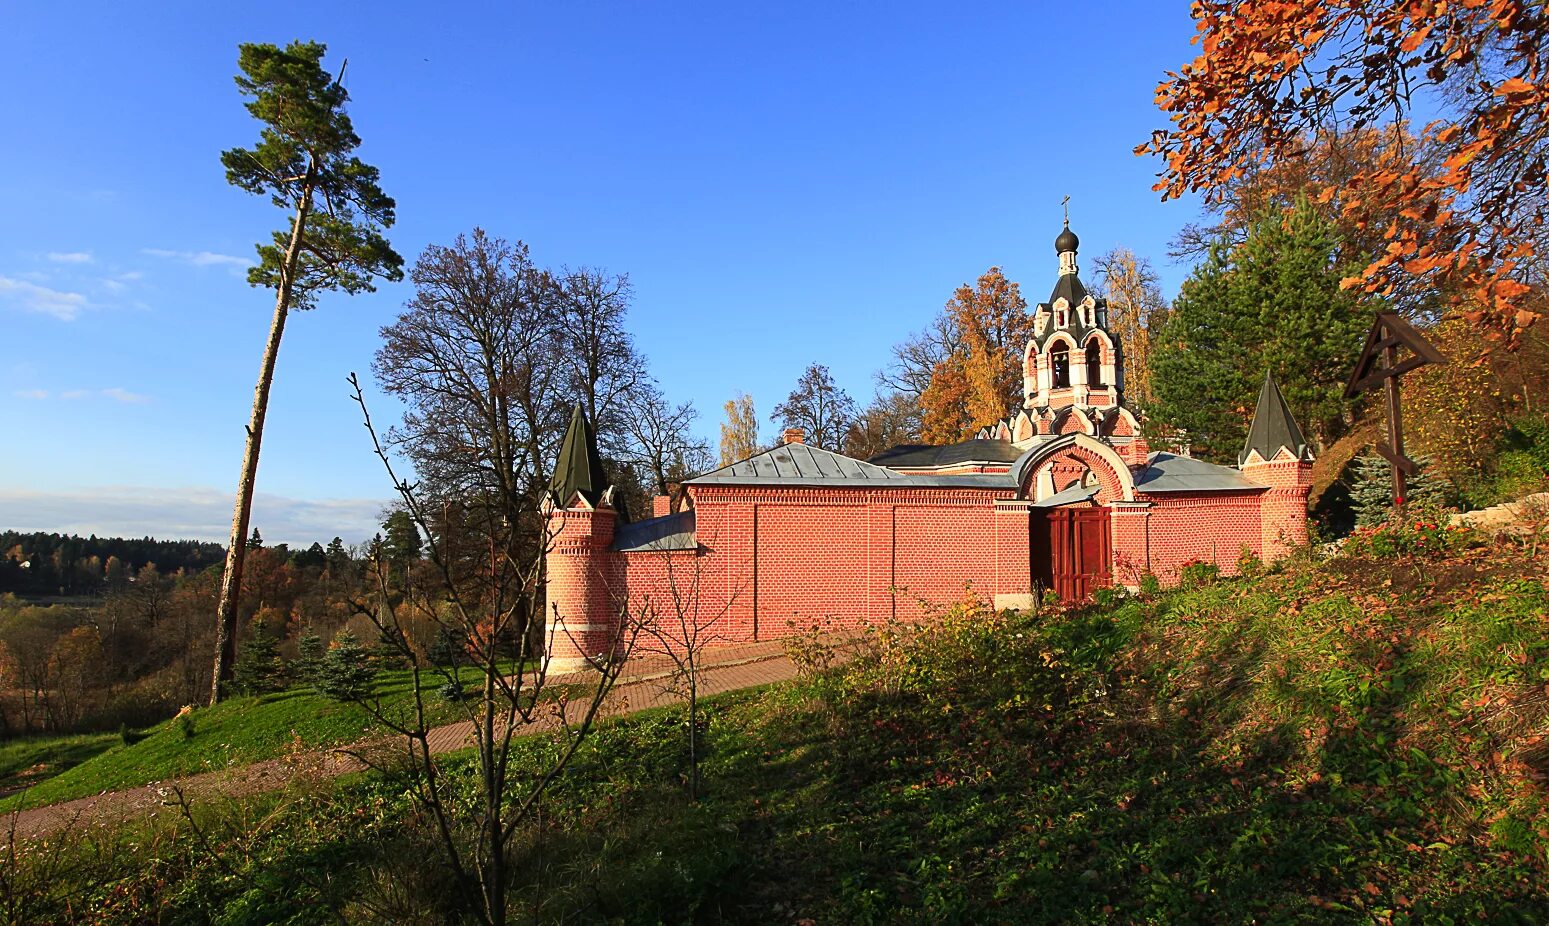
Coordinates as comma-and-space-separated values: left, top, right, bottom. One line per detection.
0, 486, 387, 547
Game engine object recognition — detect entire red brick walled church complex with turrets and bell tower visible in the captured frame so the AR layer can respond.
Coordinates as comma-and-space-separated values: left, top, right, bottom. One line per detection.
545, 225, 1312, 669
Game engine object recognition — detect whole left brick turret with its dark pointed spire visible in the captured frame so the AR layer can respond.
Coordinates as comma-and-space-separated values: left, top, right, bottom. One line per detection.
544, 406, 624, 672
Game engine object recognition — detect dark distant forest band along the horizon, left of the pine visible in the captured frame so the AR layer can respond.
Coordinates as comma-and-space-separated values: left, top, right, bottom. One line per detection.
0, 531, 226, 595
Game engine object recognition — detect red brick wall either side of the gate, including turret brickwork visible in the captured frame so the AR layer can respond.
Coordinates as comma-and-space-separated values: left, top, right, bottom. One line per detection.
548, 470, 1307, 657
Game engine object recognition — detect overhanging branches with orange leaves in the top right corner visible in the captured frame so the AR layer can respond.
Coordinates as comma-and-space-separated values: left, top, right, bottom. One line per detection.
1135, 0, 1549, 341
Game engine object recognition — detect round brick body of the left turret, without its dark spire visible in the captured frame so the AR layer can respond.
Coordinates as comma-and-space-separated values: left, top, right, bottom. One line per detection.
544, 508, 624, 672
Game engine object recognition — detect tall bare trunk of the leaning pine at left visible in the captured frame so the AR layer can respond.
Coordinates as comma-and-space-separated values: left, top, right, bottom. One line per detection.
209, 179, 313, 705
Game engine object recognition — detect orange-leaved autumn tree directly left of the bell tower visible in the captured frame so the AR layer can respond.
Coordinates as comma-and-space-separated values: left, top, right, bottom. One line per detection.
920, 266, 1033, 443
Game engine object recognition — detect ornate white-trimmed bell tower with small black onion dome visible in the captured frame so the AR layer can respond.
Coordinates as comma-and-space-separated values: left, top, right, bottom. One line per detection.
1022, 218, 1125, 412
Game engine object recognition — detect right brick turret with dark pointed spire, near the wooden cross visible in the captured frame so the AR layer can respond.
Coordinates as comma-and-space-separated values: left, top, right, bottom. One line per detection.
1238, 372, 1312, 562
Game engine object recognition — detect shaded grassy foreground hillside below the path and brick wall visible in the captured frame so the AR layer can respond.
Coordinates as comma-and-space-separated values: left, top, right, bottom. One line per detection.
15, 528, 1549, 923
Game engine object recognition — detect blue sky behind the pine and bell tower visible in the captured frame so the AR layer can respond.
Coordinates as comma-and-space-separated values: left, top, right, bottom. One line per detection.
0, 0, 1197, 542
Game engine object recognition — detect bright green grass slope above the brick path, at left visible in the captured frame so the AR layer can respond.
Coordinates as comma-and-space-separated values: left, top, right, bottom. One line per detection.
0, 667, 508, 811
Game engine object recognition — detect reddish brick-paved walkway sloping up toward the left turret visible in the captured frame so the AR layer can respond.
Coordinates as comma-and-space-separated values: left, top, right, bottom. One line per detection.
12, 643, 796, 844
